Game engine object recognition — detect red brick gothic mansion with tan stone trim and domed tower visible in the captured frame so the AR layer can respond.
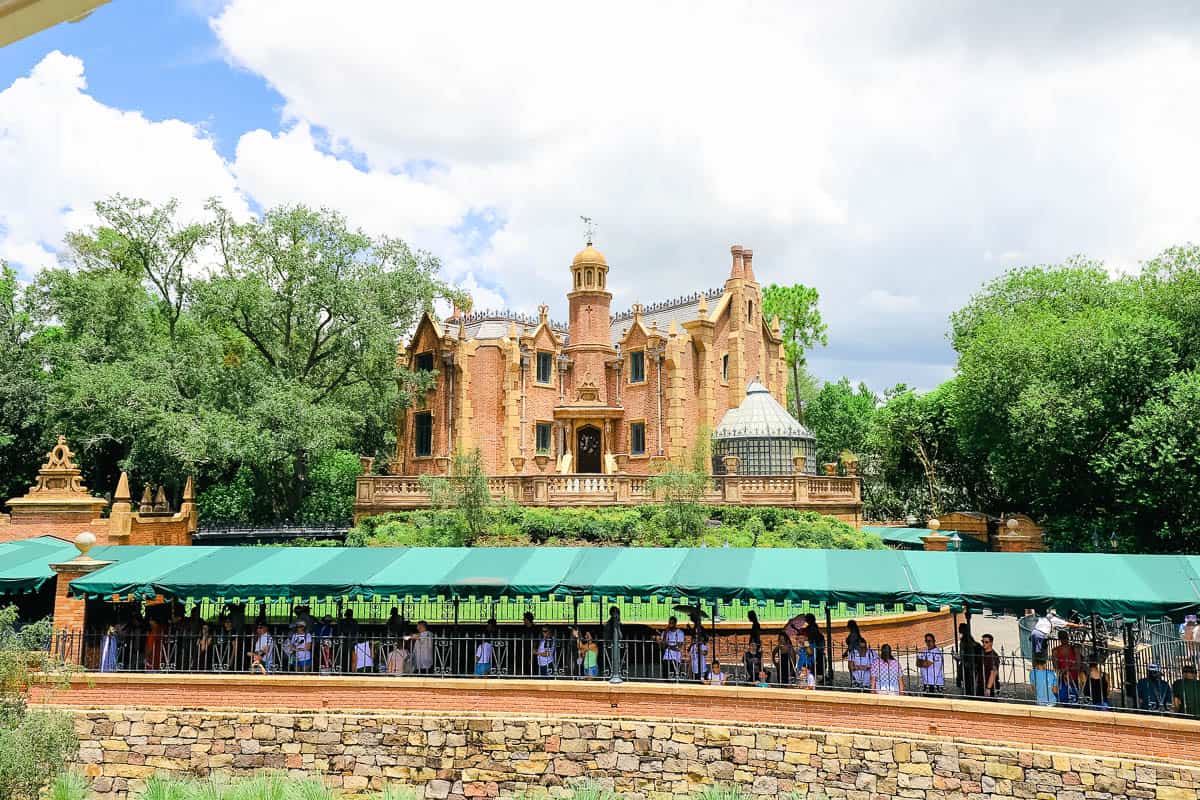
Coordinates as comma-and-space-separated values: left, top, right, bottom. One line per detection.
389, 242, 787, 475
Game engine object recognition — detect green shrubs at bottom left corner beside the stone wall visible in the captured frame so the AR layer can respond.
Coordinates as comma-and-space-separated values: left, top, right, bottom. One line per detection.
0, 606, 79, 800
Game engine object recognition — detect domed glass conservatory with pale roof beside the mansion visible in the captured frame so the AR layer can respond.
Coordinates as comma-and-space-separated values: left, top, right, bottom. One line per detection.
713, 380, 817, 475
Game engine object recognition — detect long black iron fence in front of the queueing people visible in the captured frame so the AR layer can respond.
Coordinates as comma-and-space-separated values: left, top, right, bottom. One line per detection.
44, 626, 1200, 716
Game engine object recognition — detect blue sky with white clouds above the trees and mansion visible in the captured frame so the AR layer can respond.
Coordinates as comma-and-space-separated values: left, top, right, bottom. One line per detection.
0, 0, 1200, 391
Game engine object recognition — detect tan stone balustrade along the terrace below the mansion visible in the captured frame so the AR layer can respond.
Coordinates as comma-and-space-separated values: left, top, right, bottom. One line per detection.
354, 474, 862, 522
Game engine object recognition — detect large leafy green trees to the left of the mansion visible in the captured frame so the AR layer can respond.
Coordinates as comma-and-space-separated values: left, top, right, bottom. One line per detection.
0, 197, 461, 524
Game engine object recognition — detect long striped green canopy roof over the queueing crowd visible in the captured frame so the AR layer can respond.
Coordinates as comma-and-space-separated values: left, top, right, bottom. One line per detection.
63, 547, 1200, 615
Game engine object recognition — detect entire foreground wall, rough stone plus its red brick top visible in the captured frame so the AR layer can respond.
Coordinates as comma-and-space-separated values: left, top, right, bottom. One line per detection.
63, 676, 1200, 800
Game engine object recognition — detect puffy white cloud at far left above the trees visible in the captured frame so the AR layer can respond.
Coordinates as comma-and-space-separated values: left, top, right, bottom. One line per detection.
0, 50, 245, 272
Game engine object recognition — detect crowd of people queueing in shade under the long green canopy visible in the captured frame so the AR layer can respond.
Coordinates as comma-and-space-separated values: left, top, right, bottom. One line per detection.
77, 603, 1200, 717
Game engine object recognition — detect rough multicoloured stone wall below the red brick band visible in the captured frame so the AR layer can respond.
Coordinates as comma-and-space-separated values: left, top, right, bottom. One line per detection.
74, 709, 1200, 800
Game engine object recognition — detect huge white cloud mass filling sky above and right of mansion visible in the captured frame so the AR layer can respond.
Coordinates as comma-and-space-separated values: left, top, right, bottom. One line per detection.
204, 0, 1200, 388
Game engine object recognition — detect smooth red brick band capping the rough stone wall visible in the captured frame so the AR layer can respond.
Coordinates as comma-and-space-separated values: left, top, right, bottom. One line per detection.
38, 674, 1200, 769
